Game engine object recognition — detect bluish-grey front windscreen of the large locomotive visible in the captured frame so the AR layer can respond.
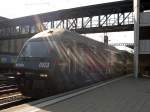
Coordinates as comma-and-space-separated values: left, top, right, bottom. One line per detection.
20, 41, 54, 57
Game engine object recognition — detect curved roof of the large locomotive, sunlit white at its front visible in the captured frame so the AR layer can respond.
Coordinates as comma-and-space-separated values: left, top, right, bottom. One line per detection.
28, 29, 118, 52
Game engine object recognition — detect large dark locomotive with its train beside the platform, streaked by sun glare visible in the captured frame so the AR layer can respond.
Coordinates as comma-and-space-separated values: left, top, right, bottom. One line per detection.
15, 29, 133, 98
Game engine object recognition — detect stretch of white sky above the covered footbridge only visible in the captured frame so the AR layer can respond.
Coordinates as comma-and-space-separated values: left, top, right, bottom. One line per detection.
0, 0, 119, 18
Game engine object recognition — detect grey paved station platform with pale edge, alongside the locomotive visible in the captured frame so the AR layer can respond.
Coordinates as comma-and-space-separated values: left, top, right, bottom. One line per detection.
2, 76, 150, 112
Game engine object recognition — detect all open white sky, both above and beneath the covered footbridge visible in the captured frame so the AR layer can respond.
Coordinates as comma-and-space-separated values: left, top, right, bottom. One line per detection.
0, 0, 133, 50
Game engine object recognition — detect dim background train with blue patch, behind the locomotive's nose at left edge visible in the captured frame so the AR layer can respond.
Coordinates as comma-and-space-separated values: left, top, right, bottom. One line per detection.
0, 38, 27, 73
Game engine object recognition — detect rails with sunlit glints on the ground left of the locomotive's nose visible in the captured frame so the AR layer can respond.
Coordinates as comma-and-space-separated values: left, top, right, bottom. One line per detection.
0, 73, 27, 110
